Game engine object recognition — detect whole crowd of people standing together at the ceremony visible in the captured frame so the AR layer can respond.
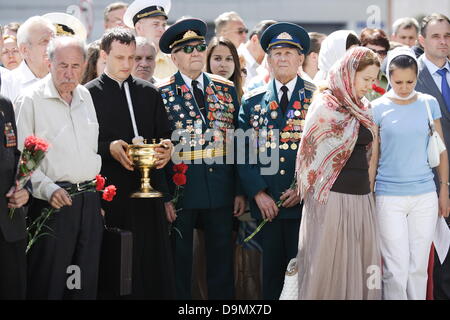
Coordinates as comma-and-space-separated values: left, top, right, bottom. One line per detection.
0, 0, 450, 300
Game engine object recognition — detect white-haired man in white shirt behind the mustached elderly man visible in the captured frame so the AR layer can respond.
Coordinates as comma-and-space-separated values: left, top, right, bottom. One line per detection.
0, 16, 55, 102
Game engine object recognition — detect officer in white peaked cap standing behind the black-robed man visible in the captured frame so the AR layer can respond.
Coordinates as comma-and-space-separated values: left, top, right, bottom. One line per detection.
123, 0, 178, 80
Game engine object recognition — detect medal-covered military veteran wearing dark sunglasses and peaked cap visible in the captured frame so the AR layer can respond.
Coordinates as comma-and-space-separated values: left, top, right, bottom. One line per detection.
159, 19, 245, 299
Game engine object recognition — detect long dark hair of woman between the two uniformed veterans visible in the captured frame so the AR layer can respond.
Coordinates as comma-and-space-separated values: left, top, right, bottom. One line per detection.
206, 37, 244, 103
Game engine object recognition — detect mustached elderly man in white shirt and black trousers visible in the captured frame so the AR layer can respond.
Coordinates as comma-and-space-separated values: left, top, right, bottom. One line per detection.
15, 37, 102, 299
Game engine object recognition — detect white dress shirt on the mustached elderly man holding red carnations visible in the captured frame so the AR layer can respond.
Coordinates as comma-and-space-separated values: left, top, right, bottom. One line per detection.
15, 74, 101, 201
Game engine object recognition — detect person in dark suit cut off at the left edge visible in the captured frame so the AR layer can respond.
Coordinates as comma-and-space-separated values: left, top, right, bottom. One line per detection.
0, 96, 29, 299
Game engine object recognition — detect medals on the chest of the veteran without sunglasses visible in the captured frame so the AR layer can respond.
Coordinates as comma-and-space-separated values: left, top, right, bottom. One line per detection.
250, 101, 309, 152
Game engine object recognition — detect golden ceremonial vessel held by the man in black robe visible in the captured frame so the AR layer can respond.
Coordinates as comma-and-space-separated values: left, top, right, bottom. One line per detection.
127, 139, 163, 198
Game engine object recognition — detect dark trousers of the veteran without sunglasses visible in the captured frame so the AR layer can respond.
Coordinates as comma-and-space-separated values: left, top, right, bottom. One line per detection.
258, 219, 300, 300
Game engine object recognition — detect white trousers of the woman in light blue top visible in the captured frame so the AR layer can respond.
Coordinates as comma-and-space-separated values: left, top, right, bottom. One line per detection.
376, 192, 438, 300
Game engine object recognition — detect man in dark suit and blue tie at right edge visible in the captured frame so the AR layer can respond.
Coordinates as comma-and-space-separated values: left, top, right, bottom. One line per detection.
416, 14, 450, 299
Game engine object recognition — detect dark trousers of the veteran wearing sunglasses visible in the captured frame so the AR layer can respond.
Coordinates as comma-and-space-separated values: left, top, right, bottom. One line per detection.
172, 207, 234, 300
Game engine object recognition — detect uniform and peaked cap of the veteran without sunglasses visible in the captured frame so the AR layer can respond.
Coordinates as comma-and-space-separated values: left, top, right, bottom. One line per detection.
238, 23, 315, 299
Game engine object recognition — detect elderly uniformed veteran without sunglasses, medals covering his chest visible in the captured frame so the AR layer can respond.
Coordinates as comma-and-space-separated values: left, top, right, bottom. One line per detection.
239, 22, 315, 300
